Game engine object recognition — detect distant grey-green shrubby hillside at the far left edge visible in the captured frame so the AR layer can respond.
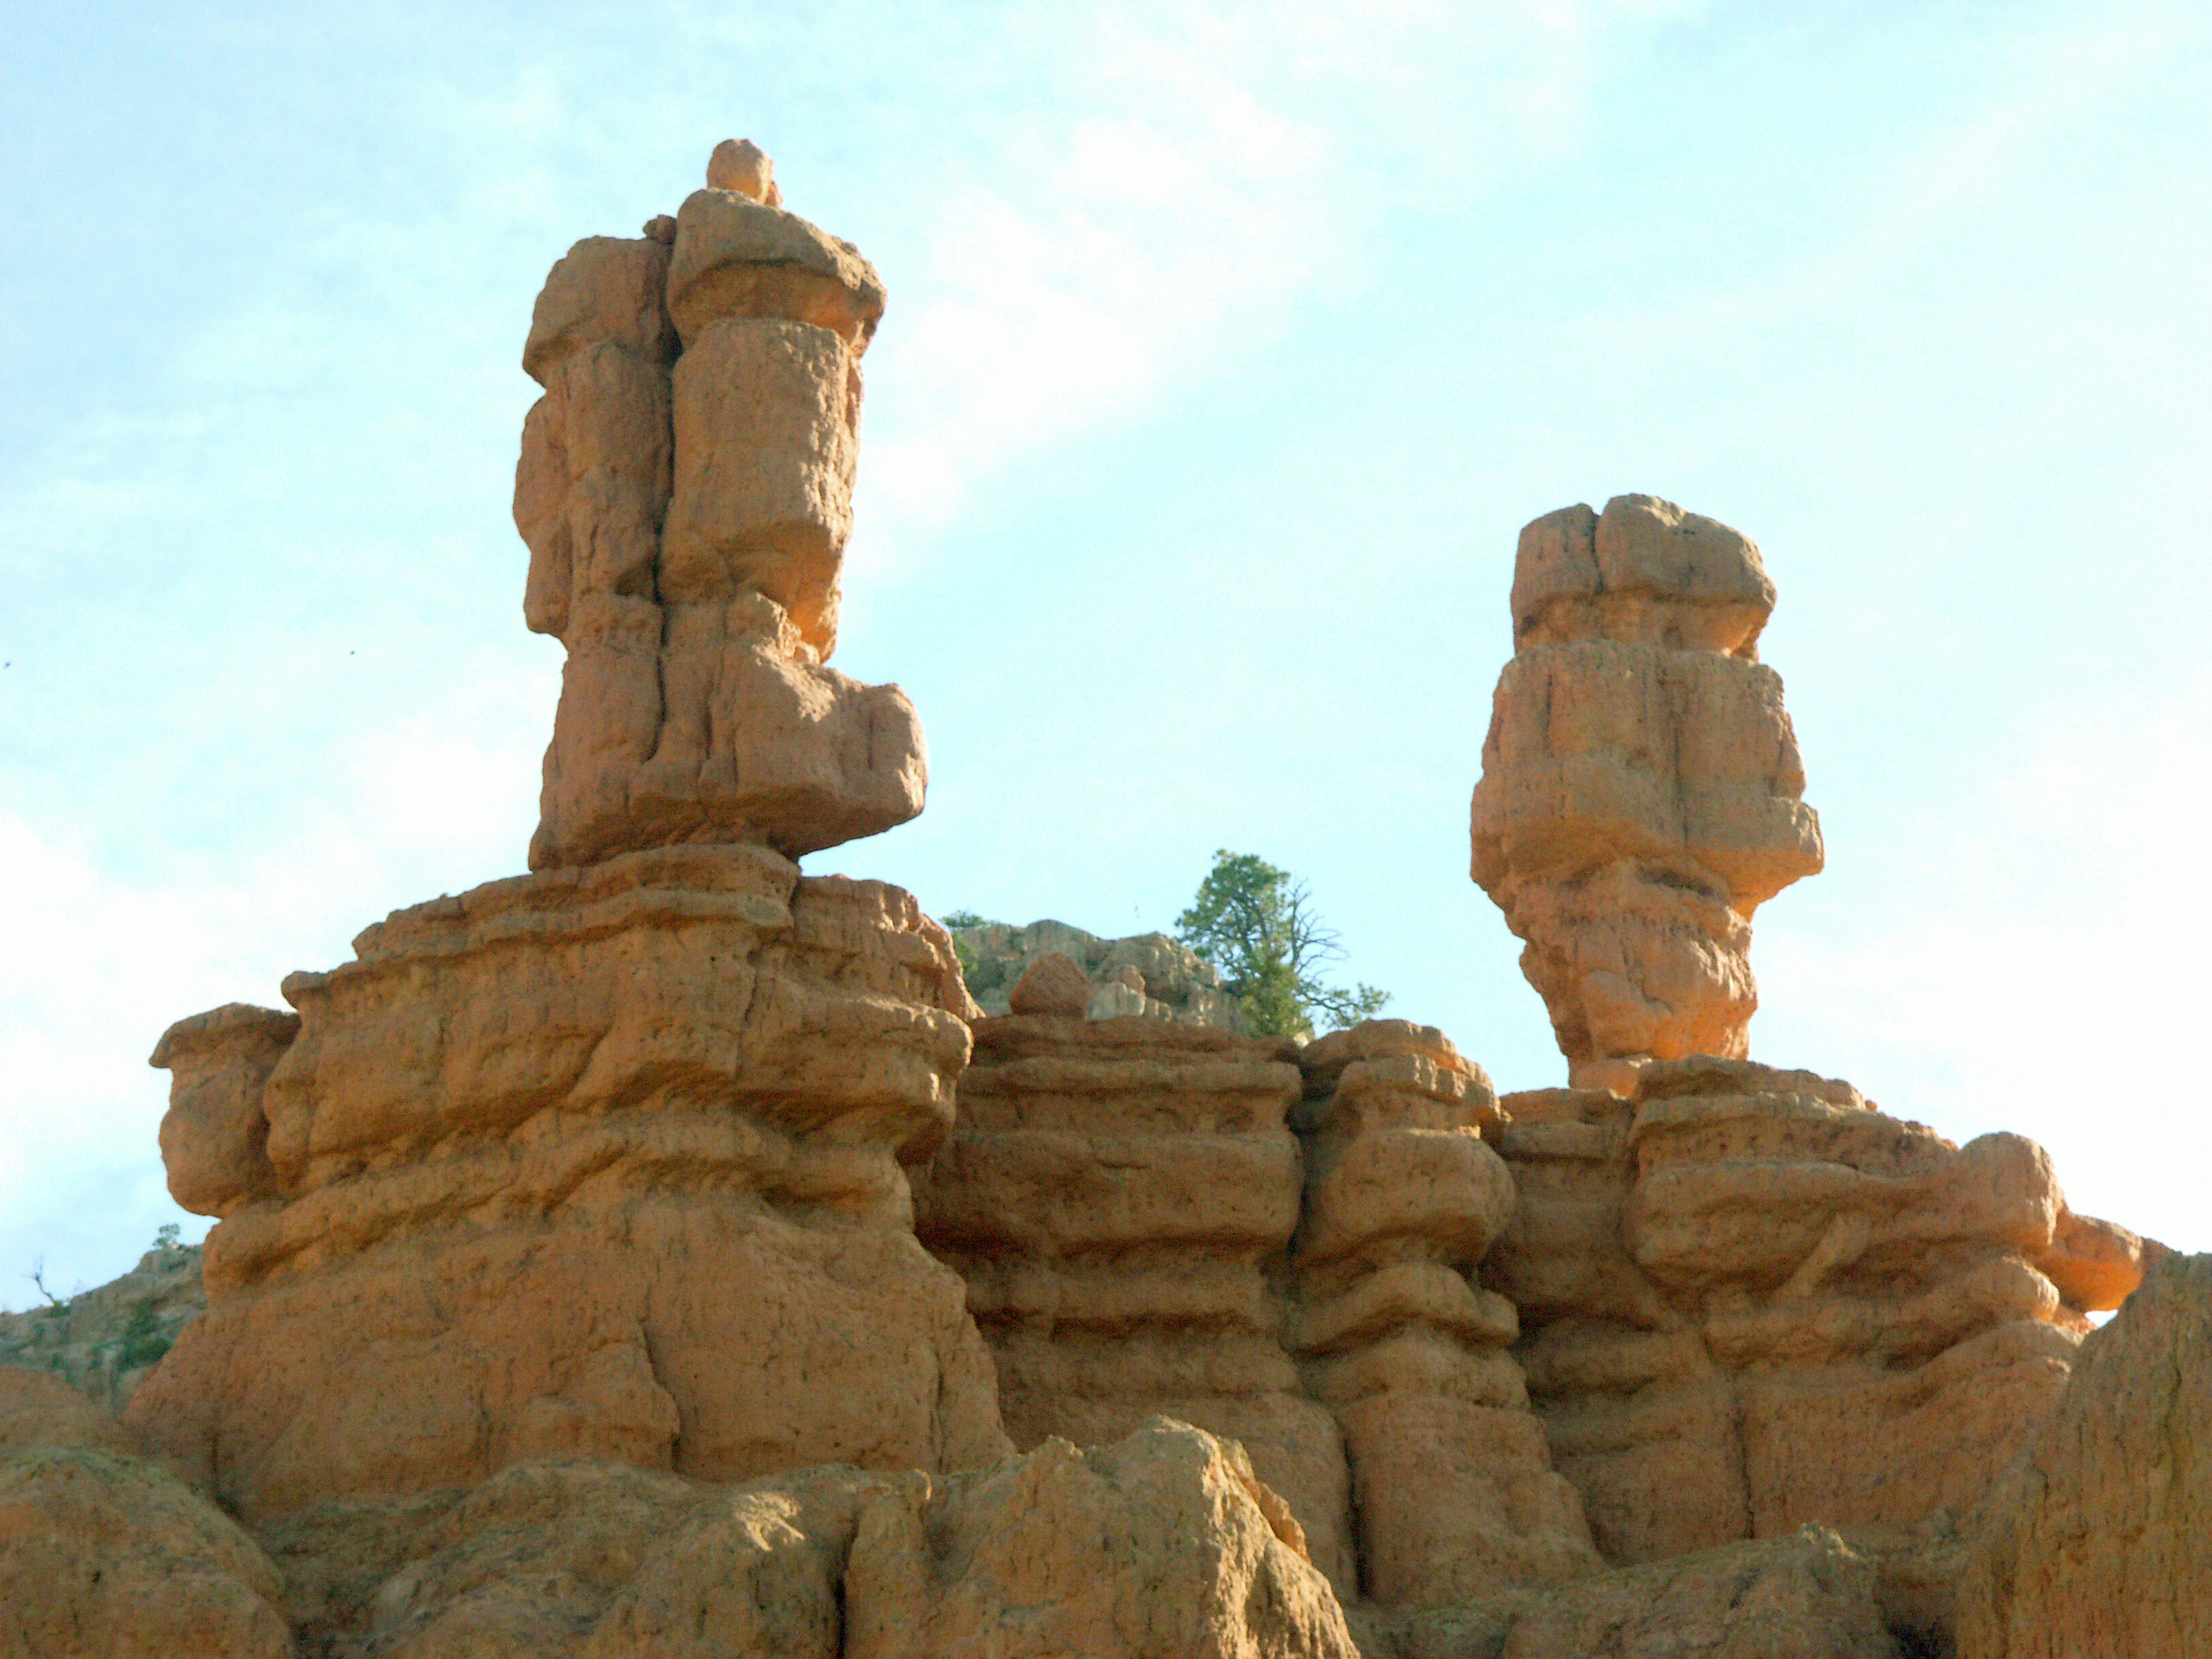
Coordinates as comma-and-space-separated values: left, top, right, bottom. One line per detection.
0, 1245, 208, 1411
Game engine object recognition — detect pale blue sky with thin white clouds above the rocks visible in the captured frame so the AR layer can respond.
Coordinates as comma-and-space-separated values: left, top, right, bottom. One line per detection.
0, 0, 2212, 1305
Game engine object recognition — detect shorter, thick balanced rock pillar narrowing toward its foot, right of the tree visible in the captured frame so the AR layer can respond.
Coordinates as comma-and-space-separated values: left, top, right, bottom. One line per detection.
1471, 495, 1823, 1088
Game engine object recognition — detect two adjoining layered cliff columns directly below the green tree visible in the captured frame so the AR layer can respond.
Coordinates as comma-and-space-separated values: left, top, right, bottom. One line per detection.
918, 1013, 1597, 1604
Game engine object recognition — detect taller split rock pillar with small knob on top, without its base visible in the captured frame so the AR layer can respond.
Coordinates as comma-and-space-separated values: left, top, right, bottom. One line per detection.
516, 142, 927, 869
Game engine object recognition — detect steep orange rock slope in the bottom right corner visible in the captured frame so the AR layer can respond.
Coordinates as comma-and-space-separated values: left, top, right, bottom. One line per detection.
1960, 1256, 2212, 1659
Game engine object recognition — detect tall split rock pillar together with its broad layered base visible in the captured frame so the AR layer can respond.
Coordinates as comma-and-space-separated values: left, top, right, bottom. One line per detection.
131, 150, 1006, 1520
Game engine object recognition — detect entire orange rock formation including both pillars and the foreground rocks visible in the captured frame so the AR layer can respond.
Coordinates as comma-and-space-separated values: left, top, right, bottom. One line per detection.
17, 142, 2212, 1659
